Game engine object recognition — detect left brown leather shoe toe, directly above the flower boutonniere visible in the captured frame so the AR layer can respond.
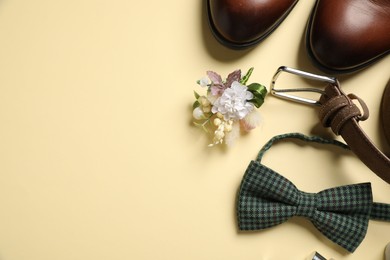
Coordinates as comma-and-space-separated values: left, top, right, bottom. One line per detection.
206, 0, 298, 49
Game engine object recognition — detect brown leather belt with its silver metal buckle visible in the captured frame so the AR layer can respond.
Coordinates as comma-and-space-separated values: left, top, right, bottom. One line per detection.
271, 66, 390, 183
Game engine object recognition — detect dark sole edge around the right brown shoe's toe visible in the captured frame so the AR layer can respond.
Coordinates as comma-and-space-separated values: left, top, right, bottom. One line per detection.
305, 0, 390, 75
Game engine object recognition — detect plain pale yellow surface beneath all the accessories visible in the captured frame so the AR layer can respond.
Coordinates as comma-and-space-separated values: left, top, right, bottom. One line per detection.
0, 0, 390, 260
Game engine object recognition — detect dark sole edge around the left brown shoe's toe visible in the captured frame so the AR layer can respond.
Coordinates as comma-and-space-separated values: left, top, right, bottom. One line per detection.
205, 0, 299, 50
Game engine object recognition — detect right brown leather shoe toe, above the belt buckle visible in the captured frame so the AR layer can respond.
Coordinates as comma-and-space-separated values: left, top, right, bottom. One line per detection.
306, 0, 390, 73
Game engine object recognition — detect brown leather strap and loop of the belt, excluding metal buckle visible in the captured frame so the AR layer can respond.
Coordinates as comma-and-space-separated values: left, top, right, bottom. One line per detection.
319, 85, 390, 183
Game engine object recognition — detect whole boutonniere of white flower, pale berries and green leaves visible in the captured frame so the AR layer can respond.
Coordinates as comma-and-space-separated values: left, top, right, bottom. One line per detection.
193, 68, 267, 146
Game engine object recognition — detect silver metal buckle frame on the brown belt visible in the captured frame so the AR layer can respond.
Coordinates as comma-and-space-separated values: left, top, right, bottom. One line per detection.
271, 66, 339, 106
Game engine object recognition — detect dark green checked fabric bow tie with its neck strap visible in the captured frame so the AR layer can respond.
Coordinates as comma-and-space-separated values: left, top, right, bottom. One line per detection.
237, 133, 390, 252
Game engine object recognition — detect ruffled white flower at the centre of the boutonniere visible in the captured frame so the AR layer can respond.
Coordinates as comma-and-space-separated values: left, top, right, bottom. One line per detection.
211, 81, 254, 120
